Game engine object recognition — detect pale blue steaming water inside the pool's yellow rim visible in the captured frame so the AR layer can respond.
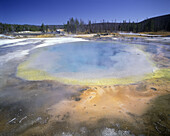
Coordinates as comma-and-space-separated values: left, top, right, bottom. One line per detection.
30, 42, 152, 78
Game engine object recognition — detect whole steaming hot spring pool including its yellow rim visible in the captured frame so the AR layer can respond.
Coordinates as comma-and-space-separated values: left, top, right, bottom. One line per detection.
18, 41, 154, 84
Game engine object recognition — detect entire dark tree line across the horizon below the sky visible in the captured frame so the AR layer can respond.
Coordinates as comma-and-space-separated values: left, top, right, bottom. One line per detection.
0, 14, 170, 33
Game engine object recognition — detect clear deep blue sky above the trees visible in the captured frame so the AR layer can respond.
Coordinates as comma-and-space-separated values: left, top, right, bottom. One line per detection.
0, 0, 170, 25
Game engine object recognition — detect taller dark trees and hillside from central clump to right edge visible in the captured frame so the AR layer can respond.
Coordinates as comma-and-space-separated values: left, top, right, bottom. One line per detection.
64, 15, 170, 33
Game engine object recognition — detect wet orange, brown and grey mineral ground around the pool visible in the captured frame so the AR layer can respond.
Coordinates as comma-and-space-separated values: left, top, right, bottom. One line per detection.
0, 36, 170, 136
